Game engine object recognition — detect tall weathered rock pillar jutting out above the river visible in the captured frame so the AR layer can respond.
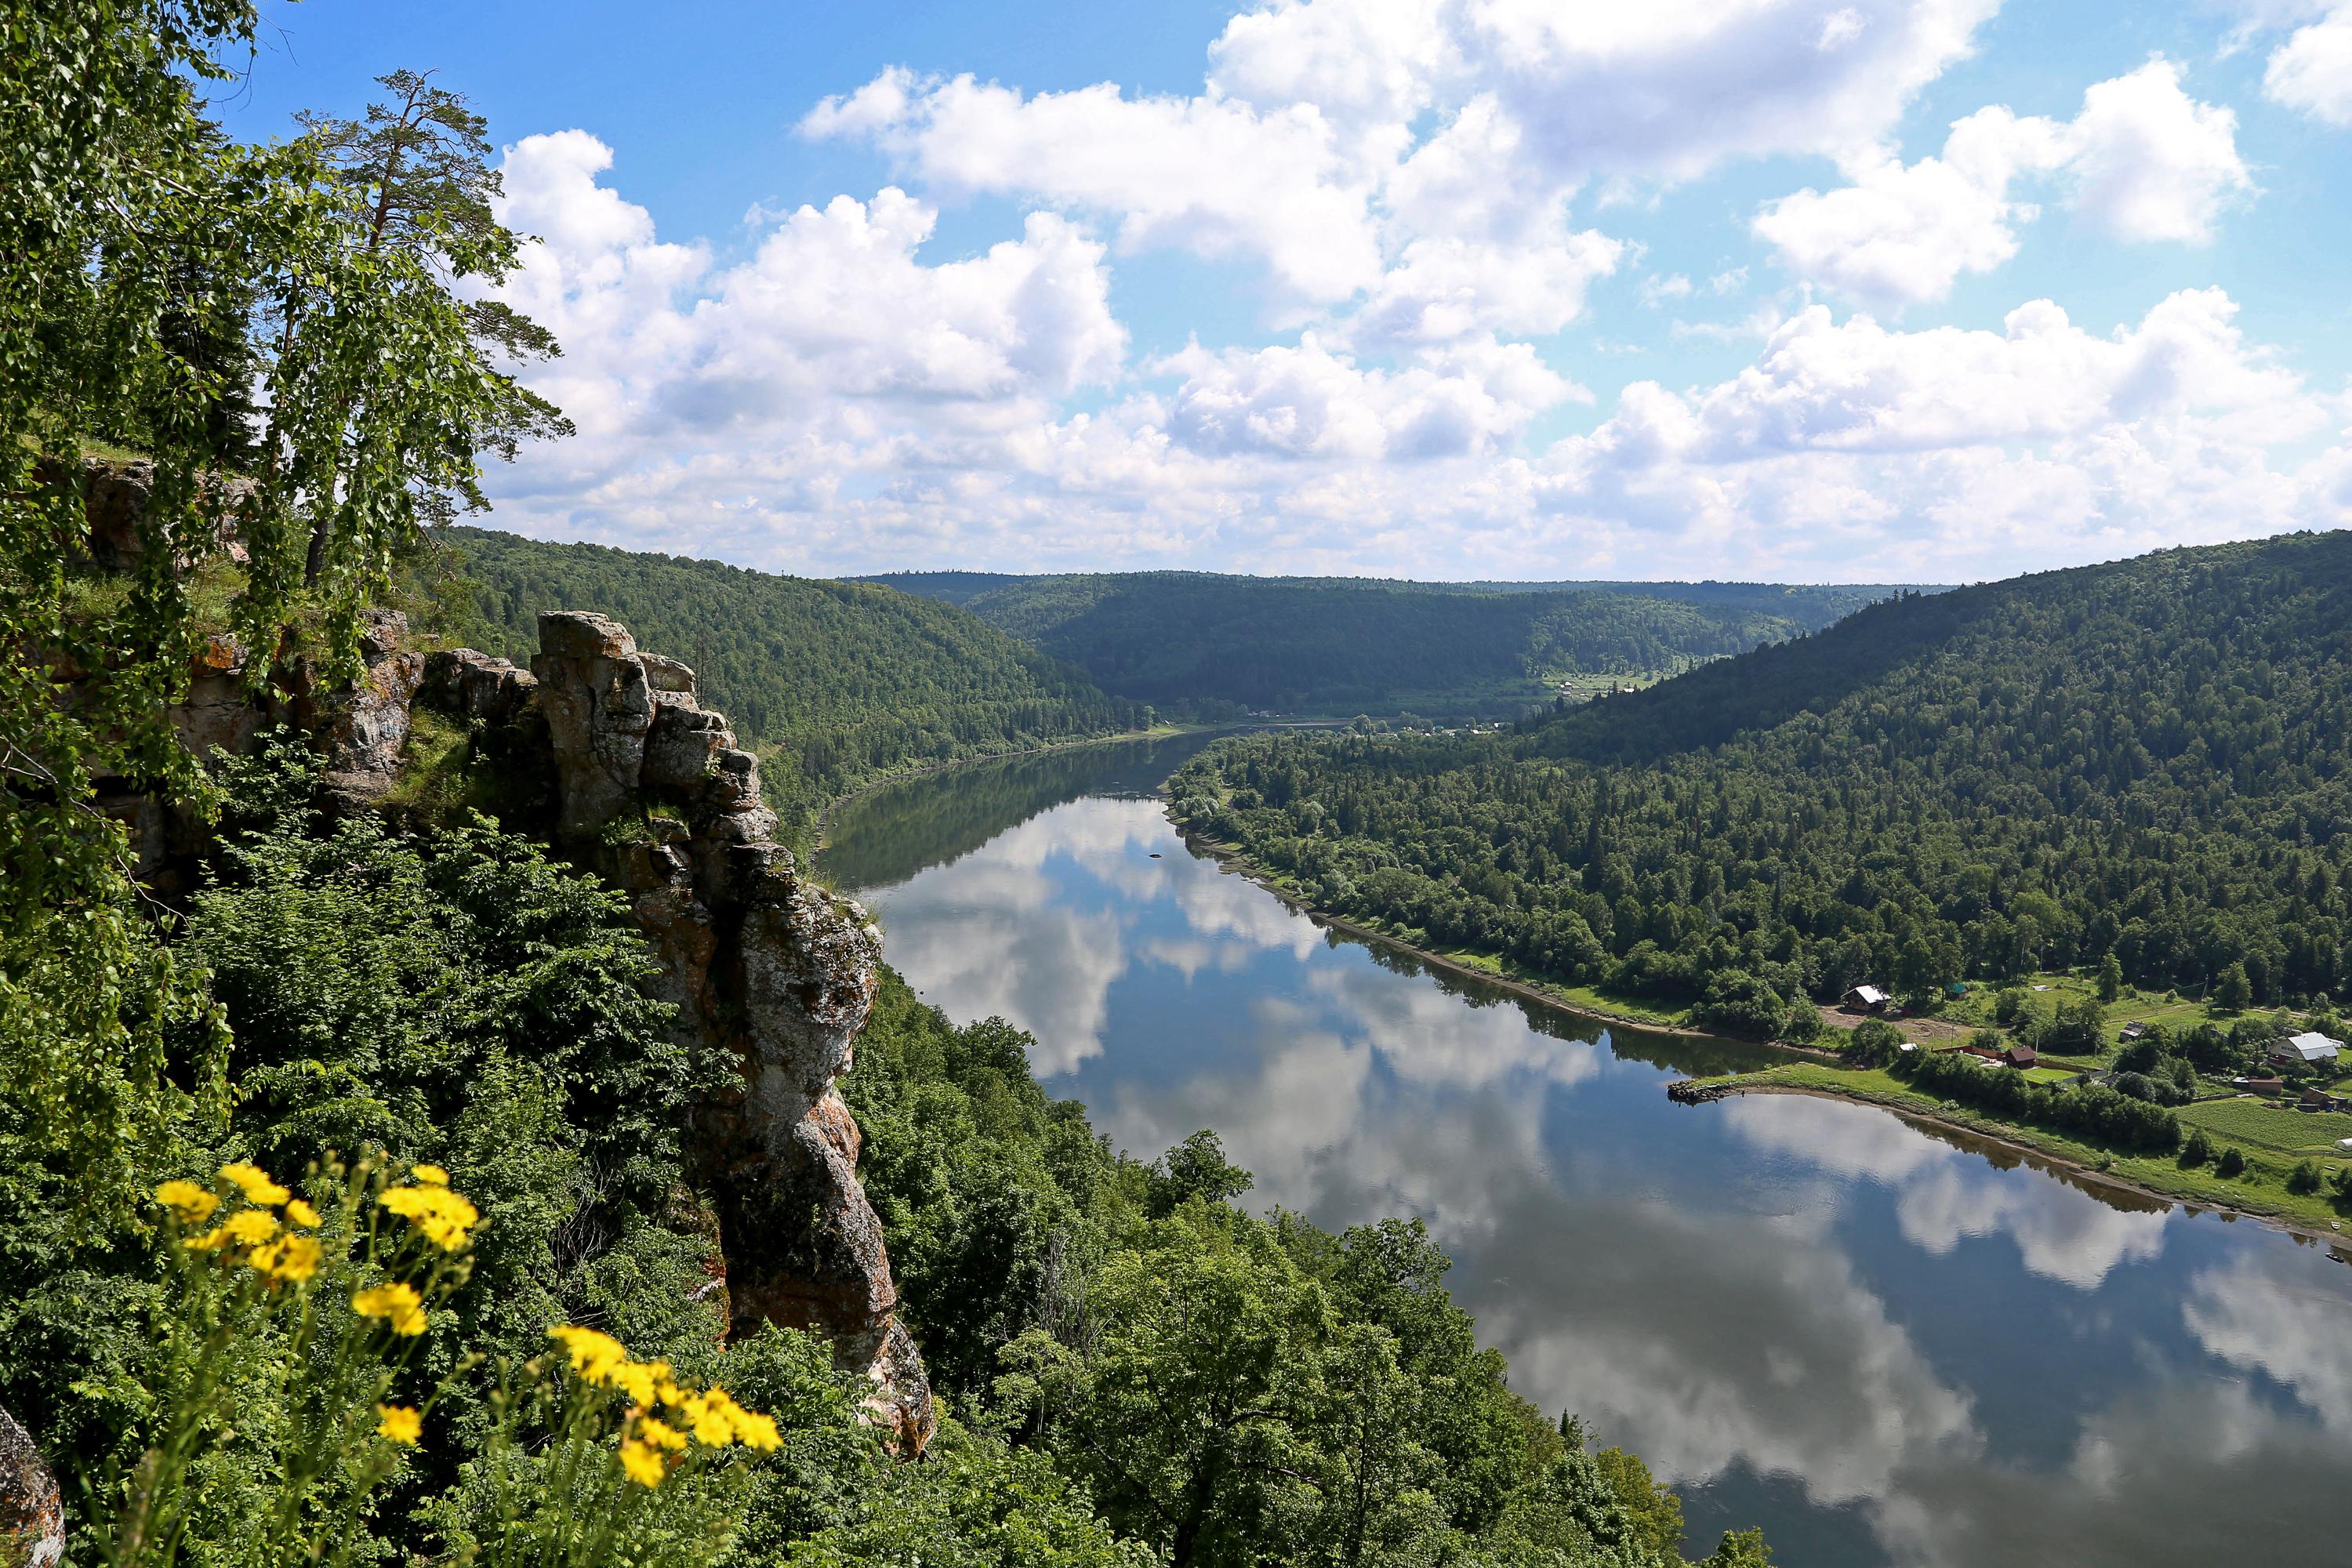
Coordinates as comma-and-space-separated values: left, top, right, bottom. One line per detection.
423, 612, 934, 1450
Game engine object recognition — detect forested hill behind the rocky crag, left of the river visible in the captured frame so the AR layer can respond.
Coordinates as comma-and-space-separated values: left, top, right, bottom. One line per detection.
447, 529, 1145, 832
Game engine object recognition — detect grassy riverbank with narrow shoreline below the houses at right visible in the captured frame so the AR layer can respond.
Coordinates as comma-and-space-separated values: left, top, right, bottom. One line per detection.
1693, 1062, 2352, 1262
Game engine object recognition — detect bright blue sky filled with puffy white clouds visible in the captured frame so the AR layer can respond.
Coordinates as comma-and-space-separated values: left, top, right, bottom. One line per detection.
223, 0, 2352, 581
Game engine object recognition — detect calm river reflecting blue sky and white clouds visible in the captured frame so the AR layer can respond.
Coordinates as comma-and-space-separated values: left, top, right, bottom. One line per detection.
826, 739, 2352, 1568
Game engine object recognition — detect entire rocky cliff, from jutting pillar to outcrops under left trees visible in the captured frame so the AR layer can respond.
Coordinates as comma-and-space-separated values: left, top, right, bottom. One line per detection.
137, 612, 934, 1453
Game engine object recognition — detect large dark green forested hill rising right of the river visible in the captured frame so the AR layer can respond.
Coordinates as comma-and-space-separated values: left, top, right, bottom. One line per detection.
1176, 534, 2352, 1027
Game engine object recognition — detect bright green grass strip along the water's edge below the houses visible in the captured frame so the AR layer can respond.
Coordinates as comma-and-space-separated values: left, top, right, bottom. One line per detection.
1703, 1062, 2352, 1243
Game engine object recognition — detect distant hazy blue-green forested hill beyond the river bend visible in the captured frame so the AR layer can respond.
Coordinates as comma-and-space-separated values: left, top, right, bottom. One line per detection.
851, 572, 1875, 715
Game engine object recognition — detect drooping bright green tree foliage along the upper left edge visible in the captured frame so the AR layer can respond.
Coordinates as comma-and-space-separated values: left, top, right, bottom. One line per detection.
0, 0, 564, 1213
